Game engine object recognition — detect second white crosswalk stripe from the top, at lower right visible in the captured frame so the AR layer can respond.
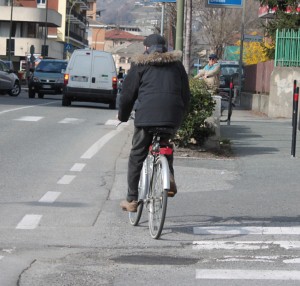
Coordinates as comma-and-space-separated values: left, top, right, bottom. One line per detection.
193, 240, 300, 250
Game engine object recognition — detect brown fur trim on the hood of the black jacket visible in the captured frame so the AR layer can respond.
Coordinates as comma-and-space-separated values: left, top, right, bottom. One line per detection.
132, 51, 182, 65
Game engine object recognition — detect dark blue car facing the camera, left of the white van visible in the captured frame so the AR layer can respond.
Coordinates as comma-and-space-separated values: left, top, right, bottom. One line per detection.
28, 59, 68, 98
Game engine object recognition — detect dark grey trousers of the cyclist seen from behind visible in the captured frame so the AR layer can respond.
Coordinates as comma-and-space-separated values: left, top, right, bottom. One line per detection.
127, 127, 174, 202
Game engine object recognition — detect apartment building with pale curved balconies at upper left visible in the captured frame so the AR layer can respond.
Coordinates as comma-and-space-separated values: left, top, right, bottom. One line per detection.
0, 0, 97, 70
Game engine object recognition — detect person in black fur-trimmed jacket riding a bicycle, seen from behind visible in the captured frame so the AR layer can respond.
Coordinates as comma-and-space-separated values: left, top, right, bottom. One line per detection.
118, 34, 190, 212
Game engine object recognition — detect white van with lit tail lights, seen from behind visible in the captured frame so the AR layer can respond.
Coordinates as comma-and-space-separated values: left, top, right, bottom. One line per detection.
62, 49, 118, 109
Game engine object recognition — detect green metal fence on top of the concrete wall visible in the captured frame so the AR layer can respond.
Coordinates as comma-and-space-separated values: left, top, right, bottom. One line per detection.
275, 29, 300, 67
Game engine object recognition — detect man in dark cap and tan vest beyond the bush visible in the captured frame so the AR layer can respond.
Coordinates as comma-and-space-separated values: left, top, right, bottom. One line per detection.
194, 54, 221, 94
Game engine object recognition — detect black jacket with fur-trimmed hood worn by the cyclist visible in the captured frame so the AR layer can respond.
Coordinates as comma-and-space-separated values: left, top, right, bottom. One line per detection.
118, 51, 190, 128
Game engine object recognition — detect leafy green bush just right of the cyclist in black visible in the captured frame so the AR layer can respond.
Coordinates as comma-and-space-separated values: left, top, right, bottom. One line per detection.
174, 79, 215, 147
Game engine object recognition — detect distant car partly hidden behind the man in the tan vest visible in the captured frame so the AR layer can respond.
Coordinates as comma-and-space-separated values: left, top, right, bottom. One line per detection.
219, 61, 244, 89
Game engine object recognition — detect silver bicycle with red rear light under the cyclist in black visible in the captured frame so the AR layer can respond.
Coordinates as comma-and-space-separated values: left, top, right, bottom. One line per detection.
129, 127, 174, 239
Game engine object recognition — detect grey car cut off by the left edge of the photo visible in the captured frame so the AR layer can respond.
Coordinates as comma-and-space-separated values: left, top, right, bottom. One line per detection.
0, 60, 21, 96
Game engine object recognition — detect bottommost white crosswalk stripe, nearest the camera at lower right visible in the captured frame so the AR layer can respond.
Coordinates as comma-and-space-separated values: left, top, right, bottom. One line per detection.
196, 269, 300, 280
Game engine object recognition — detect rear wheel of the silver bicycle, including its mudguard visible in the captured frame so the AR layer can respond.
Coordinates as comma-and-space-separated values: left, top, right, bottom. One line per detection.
148, 157, 168, 239
